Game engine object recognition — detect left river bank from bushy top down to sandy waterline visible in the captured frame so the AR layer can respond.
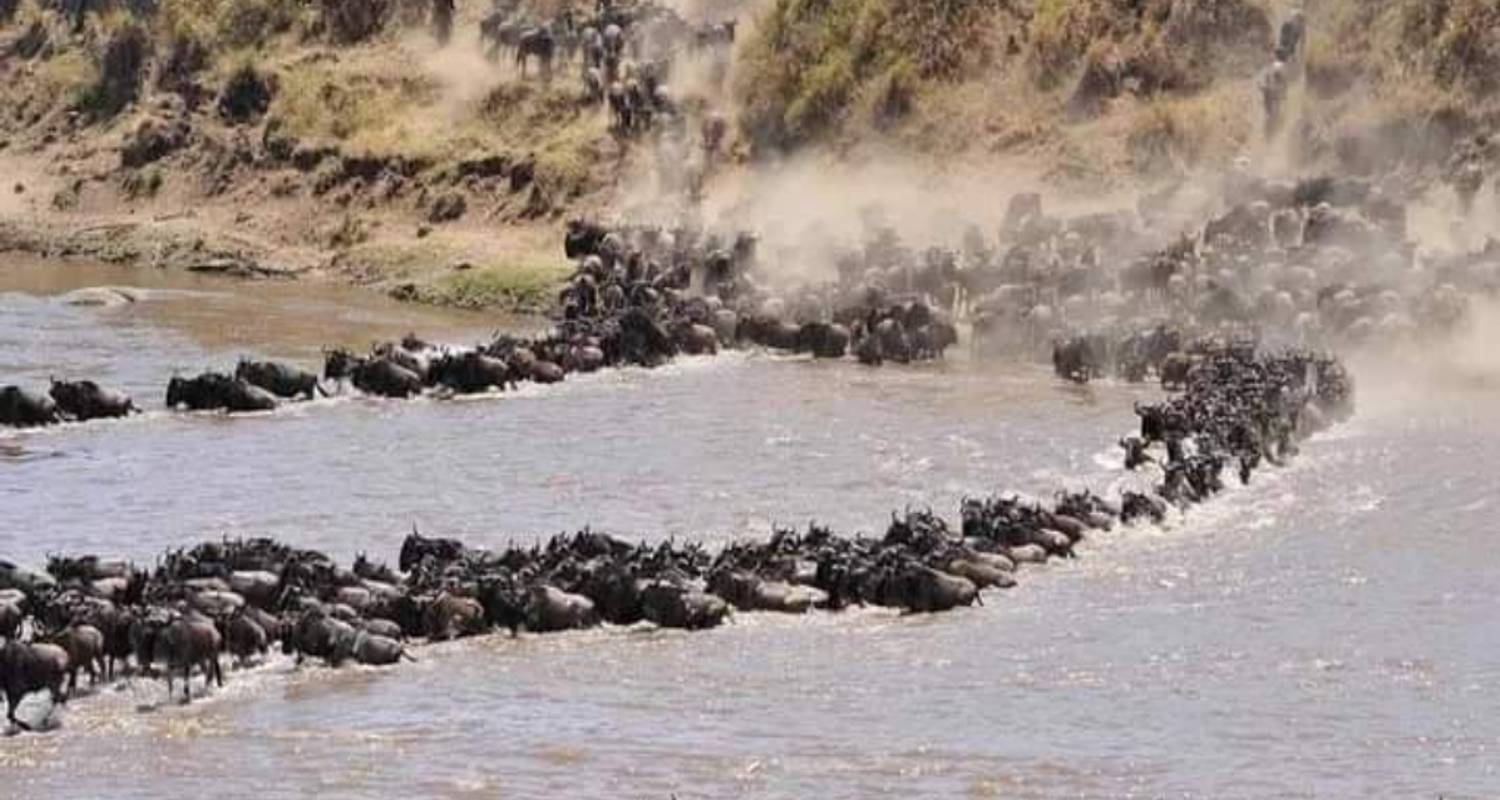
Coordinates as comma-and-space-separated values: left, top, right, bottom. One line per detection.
0, 5, 629, 311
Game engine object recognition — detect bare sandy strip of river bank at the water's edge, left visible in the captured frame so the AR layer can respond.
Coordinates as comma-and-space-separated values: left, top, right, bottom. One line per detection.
0, 132, 569, 312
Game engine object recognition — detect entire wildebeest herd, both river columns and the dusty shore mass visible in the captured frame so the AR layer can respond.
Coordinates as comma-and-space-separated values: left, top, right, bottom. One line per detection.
17, 160, 1500, 725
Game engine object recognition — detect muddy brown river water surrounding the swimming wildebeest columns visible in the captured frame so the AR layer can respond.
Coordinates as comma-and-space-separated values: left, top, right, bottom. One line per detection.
0, 257, 1500, 798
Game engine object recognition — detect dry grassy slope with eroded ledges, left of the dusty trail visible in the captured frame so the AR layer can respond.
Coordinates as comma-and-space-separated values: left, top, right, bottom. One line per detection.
0, 0, 606, 308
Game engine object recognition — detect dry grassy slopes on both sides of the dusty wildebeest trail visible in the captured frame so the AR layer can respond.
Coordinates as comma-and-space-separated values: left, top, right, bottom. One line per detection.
0, 0, 1500, 306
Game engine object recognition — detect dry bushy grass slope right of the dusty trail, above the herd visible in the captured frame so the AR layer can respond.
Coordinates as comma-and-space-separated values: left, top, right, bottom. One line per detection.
738, 0, 1500, 182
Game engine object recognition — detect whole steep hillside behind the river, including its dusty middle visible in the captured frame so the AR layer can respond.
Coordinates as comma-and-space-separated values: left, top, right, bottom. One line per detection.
0, 0, 1500, 308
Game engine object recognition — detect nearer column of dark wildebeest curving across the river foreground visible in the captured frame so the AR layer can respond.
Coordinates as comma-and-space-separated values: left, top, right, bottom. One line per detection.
0, 336, 1353, 728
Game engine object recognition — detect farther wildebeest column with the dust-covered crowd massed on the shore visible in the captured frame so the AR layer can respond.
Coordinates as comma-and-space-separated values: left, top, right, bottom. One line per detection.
0, 165, 1482, 426
